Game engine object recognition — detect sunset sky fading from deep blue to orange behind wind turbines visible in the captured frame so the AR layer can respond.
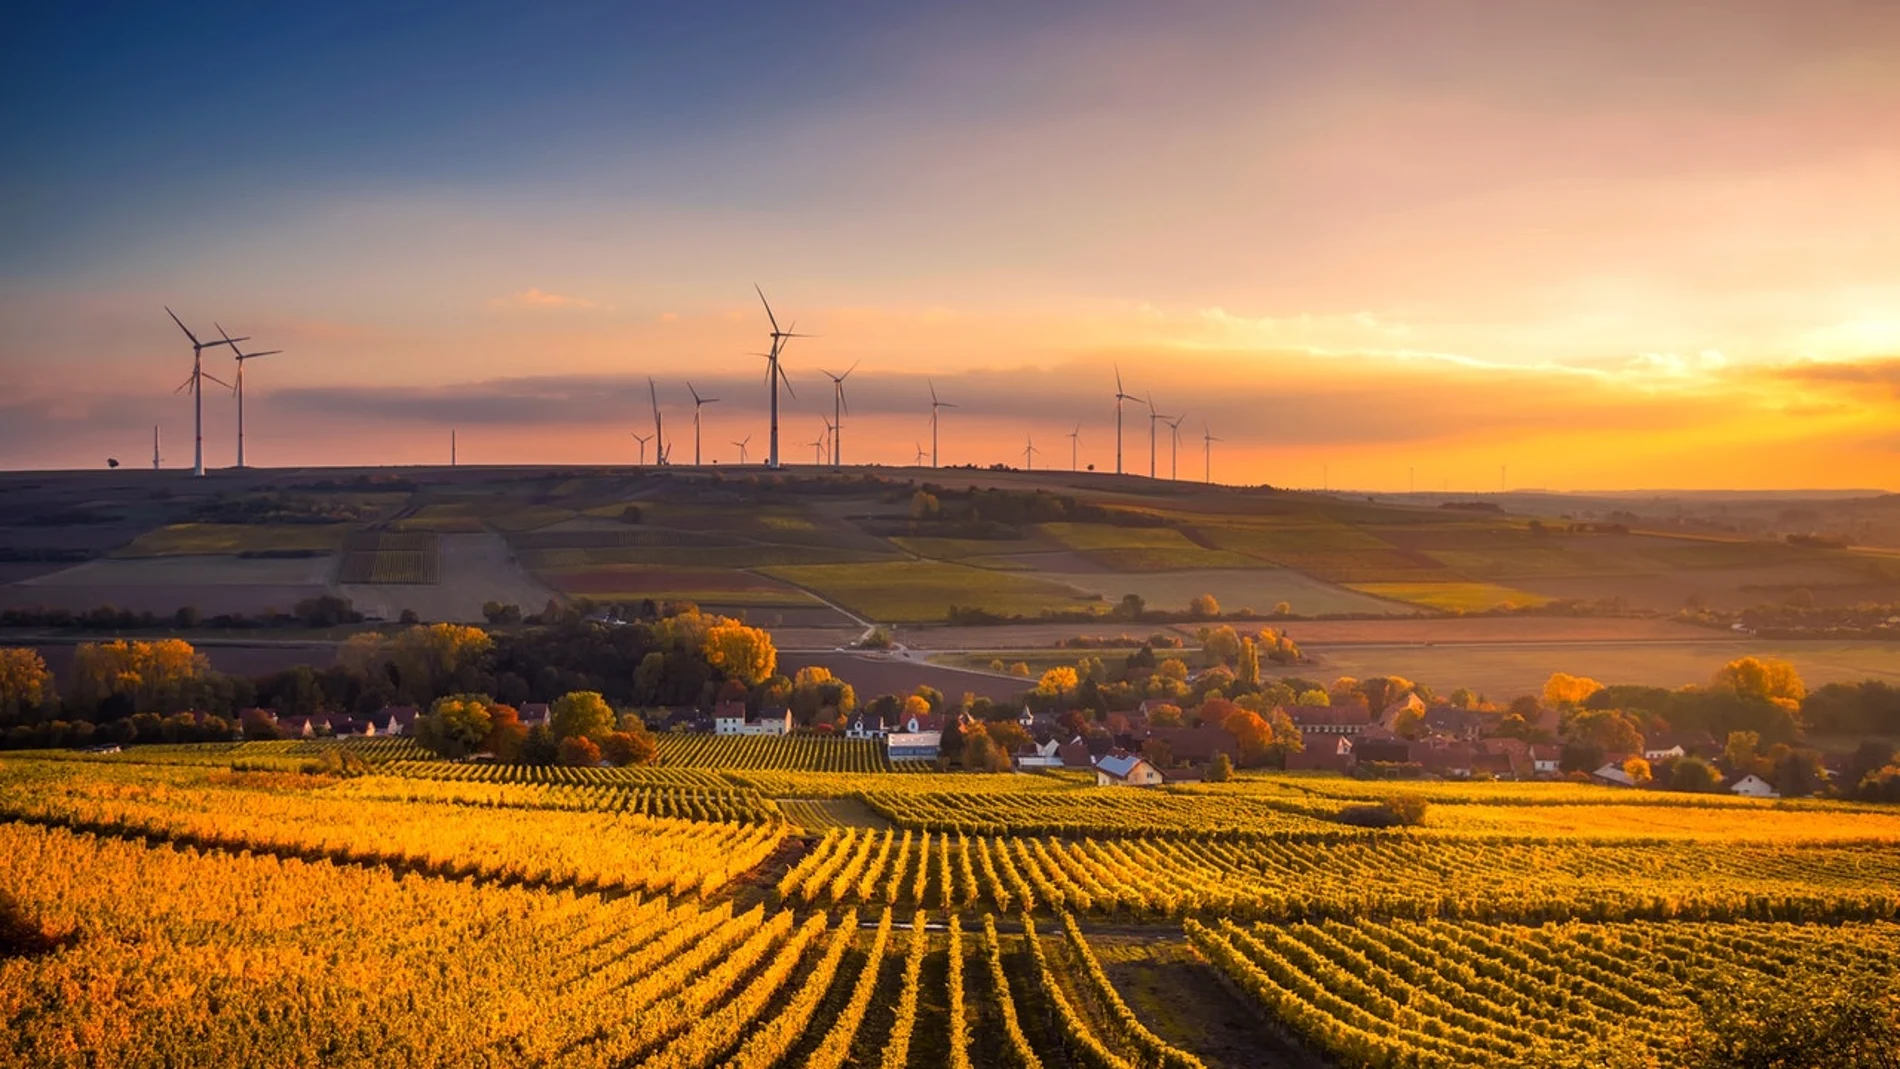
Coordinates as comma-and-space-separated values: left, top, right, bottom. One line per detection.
0, 0, 1900, 492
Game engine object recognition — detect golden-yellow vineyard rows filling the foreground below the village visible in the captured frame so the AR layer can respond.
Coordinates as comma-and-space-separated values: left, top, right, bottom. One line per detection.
0, 751, 1900, 1069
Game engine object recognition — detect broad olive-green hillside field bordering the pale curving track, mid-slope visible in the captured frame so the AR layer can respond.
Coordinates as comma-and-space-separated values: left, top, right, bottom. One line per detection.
764, 560, 1108, 623
